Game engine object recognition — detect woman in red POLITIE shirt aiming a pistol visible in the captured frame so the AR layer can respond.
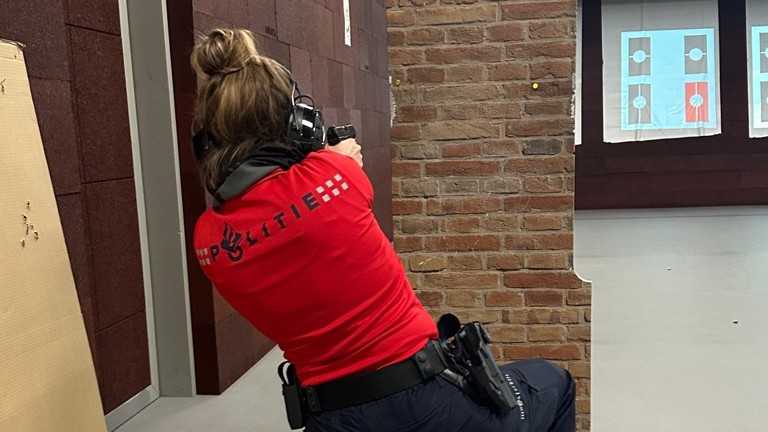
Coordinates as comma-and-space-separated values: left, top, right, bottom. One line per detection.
192, 30, 574, 432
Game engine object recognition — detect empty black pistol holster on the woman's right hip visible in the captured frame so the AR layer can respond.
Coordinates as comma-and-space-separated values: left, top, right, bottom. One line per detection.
437, 314, 517, 413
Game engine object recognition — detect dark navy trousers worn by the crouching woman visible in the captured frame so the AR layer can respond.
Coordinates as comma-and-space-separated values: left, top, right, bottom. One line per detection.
306, 360, 576, 432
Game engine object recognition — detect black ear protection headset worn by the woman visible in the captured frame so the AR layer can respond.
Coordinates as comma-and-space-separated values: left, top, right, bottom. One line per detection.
192, 63, 325, 165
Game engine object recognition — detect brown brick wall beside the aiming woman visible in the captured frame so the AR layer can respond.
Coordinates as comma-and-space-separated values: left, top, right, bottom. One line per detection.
387, 0, 591, 430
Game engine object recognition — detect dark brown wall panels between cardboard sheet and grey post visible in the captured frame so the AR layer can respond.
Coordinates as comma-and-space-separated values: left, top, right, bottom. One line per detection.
0, 0, 150, 412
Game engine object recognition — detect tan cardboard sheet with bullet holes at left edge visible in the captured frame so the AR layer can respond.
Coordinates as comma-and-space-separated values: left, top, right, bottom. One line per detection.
0, 40, 106, 432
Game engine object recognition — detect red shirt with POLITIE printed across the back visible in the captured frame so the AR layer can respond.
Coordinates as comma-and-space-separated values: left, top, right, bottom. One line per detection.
195, 150, 437, 385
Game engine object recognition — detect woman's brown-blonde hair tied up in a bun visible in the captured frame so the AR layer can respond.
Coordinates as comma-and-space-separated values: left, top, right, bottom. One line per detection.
191, 29, 293, 192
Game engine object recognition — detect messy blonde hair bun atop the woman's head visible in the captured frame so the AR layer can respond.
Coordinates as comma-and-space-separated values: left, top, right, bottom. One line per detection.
191, 29, 259, 76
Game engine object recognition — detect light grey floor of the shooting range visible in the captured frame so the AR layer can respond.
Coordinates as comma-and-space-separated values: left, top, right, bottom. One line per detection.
117, 207, 768, 432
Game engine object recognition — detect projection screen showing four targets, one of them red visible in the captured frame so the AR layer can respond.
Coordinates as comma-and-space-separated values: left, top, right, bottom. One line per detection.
602, 0, 721, 143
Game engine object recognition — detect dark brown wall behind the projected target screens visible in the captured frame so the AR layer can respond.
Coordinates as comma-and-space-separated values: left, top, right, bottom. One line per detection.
576, 0, 768, 209
